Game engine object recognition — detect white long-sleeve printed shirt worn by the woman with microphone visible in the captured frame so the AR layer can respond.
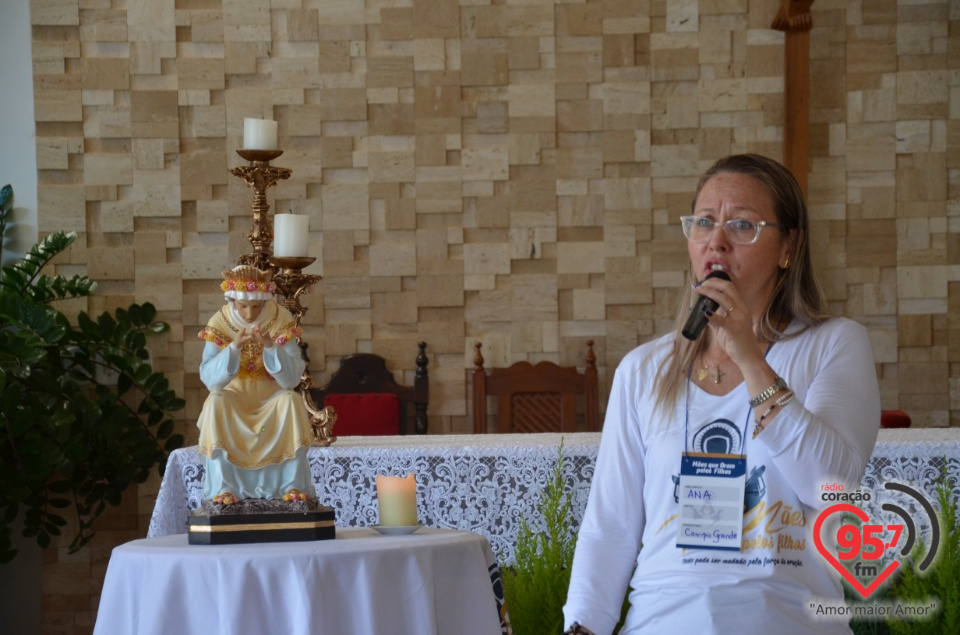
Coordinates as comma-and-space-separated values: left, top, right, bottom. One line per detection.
564, 318, 880, 635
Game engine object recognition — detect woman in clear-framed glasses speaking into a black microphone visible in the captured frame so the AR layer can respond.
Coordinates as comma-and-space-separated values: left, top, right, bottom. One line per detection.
564, 155, 880, 635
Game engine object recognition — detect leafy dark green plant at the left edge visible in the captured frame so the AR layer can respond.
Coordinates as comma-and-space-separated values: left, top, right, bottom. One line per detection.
0, 185, 184, 562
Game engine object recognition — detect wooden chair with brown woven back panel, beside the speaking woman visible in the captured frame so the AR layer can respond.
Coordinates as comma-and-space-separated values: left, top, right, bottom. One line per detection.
473, 340, 600, 434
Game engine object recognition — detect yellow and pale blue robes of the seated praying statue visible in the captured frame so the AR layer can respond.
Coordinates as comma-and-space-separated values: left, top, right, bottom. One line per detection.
197, 300, 315, 500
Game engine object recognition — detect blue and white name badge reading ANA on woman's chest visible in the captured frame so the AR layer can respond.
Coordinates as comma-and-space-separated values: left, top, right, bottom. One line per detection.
677, 452, 747, 551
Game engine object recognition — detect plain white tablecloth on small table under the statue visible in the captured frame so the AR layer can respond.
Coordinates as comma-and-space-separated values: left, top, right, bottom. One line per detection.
94, 528, 501, 635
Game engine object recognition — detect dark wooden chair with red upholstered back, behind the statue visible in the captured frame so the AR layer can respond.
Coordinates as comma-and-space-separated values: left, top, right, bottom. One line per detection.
310, 342, 430, 436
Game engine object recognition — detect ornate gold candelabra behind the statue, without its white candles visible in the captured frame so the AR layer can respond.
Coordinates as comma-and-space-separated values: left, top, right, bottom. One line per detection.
230, 150, 337, 446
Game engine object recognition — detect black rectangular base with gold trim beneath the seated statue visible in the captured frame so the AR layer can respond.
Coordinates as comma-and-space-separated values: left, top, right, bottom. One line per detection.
187, 499, 336, 545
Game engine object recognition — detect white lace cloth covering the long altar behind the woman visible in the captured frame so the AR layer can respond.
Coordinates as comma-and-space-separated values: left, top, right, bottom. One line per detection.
147, 428, 960, 564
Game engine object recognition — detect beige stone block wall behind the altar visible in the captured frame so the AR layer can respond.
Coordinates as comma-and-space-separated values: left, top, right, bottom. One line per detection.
31, 0, 960, 633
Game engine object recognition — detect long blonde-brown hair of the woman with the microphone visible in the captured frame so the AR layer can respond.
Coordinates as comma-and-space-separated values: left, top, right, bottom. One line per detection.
654, 154, 829, 415
